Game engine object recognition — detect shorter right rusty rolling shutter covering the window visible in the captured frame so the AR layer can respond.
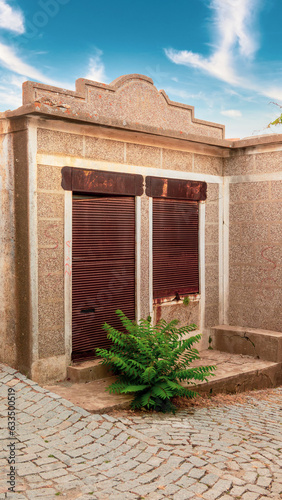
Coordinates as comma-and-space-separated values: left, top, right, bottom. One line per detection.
153, 198, 199, 299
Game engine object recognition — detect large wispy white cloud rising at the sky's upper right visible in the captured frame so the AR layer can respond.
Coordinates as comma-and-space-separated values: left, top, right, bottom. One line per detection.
165, 0, 282, 101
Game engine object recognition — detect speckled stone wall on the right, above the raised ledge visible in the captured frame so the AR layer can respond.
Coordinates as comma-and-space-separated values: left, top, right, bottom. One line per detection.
226, 151, 282, 331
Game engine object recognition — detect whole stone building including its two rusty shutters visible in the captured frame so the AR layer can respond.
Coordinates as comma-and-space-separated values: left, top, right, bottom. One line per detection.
0, 75, 282, 383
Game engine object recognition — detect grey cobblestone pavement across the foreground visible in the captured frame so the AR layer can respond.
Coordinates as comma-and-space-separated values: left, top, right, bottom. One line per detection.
0, 365, 282, 500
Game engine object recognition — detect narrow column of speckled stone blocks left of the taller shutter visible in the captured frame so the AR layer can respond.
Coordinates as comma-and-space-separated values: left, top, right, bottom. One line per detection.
37, 165, 65, 359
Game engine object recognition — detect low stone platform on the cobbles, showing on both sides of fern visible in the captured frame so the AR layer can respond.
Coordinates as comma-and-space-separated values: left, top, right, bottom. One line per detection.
45, 350, 282, 413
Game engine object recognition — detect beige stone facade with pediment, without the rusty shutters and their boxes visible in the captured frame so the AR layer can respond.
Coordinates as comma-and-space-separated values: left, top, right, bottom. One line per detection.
0, 75, 282, 383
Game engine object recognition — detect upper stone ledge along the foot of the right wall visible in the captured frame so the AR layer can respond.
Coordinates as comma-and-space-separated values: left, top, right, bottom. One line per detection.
211, 325, 282, 363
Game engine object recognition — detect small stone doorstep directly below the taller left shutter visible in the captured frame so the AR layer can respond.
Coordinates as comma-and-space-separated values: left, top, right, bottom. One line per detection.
67, 359, 113, 384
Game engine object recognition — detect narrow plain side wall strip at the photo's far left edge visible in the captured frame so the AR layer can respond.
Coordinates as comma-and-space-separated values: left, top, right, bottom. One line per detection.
0, 120, 17, 366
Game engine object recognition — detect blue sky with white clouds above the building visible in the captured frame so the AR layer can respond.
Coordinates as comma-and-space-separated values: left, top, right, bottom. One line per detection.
0, 0, 282, 138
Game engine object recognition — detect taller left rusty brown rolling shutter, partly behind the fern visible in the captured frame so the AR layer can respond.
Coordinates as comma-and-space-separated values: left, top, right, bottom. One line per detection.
72, 196, 135, 359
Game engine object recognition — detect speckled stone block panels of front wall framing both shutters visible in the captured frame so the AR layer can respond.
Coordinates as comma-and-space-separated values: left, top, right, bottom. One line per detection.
37, 127, 223, 368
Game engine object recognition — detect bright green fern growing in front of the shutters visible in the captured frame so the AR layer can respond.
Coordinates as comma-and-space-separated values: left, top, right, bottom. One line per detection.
96, 310, 215, 412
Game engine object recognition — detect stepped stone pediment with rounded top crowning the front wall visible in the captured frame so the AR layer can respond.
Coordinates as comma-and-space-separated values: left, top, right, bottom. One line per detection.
20, 74, 224, 139
